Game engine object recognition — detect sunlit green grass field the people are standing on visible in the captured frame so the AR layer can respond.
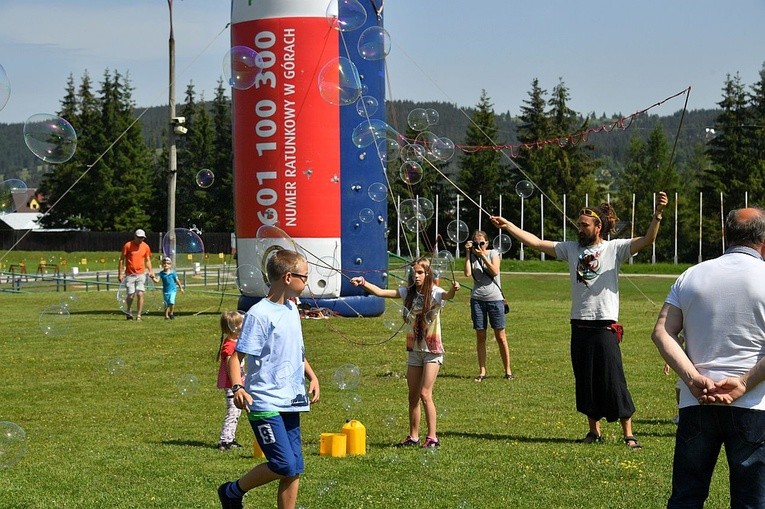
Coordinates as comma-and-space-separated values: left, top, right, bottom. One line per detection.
0, 262, 729, 509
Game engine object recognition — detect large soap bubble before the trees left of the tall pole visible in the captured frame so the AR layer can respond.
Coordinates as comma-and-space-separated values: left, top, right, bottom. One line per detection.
24, 113, 77, 164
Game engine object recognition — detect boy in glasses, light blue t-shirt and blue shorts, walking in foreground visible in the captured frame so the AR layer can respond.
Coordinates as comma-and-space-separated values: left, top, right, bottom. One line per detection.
218, 249, 319, 509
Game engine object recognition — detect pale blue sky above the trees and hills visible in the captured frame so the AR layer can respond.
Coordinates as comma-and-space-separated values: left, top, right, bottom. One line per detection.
0, 0, 765, 123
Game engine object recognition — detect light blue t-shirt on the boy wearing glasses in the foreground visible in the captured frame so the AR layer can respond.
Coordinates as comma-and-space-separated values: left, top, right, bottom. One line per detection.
236, 298, 310, 412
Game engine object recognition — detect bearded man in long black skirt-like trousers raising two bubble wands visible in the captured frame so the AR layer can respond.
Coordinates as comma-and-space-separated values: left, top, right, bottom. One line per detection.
491, 192, 667, 449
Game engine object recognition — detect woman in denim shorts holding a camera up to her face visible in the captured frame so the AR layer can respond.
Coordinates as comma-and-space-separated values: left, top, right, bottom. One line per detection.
465, 230, 515, 382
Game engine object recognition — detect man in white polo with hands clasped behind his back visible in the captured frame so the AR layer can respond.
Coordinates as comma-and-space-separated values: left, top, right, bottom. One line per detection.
652, 208, 765, 509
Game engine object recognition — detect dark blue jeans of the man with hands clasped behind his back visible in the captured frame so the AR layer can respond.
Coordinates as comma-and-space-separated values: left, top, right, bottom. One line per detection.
667, 405, 765, 509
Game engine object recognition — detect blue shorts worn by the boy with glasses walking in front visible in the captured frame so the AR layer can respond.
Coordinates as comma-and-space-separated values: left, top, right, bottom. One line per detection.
250, 412, 304, 477
